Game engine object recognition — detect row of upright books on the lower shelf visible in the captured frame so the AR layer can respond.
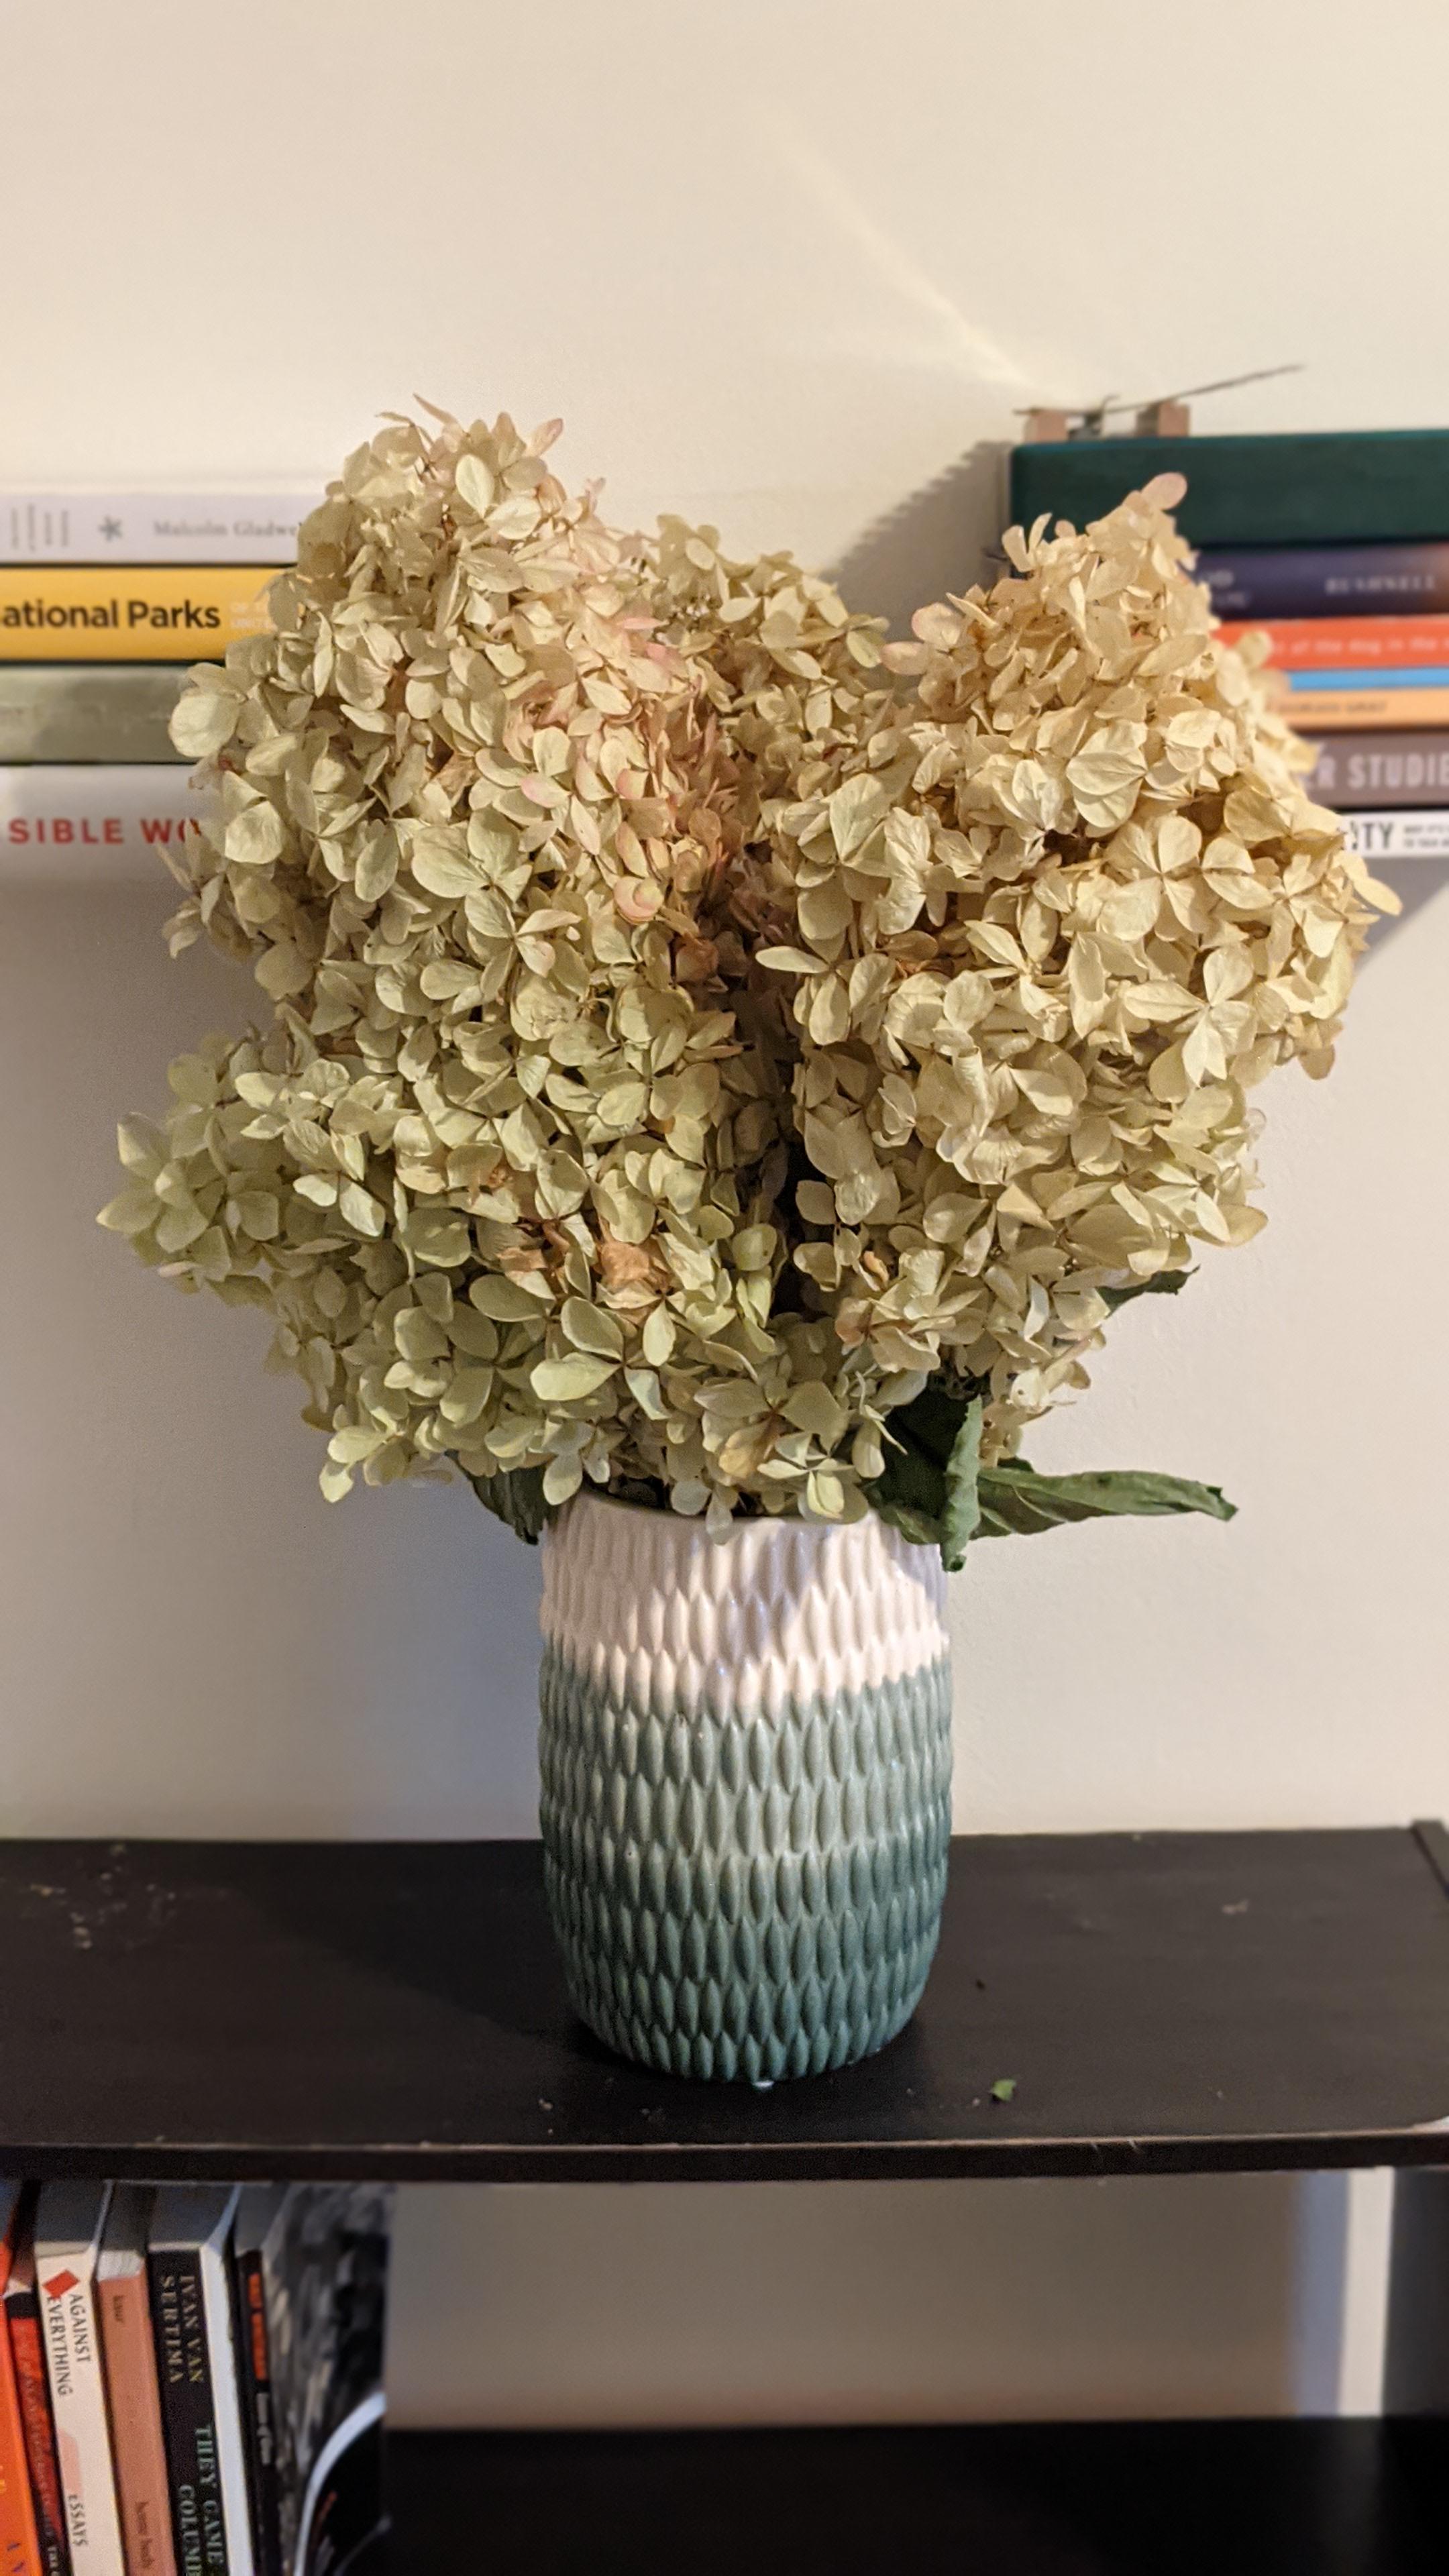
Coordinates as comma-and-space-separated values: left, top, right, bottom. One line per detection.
0, 2182, 392, 2576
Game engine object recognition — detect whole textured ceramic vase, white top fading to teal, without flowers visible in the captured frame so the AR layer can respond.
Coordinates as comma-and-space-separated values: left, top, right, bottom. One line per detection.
539, 1494, 951, 2084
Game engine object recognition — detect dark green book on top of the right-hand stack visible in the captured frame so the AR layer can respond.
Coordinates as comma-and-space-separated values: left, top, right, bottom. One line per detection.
1011, 430, 1449, 546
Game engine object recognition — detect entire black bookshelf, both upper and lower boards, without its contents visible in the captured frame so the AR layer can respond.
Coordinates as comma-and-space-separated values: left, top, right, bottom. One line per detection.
0, 1824, 1449, 2576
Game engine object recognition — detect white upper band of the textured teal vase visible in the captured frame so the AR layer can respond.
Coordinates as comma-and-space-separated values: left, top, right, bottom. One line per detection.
539, 1494, 951, 1715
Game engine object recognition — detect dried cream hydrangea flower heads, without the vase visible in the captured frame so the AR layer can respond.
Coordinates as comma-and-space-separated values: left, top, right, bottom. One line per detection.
103, 415, 1382, 1527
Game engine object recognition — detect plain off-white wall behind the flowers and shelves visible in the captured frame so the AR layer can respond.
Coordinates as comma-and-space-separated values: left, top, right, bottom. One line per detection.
0, 0, 1449, 2422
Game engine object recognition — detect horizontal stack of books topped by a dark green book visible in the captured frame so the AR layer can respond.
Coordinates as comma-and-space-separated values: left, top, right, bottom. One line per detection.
1011, 430, 1449, 861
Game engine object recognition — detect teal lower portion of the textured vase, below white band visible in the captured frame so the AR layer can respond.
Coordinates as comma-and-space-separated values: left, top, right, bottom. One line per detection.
539, 1646, 951, 2084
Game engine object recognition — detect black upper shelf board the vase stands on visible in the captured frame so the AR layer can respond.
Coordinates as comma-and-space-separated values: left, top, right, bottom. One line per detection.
0, 1827, 1449, 2182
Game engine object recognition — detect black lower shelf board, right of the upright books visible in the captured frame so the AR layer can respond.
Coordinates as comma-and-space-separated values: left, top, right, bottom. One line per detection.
387, 2419, 1449, 2576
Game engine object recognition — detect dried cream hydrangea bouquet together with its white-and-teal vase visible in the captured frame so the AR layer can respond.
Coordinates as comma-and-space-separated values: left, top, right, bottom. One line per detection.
103, 415, 1390, 2082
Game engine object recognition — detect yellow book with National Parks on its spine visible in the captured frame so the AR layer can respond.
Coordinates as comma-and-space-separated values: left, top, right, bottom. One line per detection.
0, 564, 284, 662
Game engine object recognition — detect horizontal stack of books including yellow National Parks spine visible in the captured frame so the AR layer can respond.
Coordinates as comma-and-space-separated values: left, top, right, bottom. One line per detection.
0, 492, 315, 876
